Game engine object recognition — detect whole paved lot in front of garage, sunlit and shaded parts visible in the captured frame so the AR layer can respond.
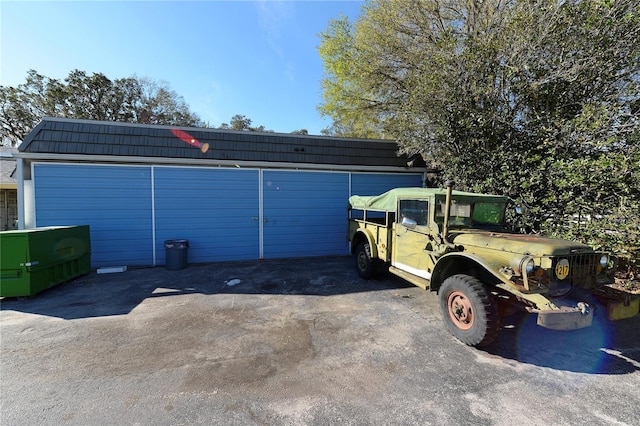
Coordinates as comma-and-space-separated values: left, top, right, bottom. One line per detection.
0, 257, 640, 426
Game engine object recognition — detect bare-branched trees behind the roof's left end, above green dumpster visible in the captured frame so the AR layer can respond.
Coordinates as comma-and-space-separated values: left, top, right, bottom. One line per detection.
0, 70, 204, 146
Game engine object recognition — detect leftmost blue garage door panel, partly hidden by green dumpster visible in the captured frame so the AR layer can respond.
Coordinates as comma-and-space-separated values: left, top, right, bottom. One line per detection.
33, 164, 153, 267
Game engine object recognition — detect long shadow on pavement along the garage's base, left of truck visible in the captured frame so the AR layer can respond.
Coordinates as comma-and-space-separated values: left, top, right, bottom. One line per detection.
0, 256, 408, 319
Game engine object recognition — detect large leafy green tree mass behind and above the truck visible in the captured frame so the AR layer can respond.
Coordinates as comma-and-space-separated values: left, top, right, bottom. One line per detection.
319, 0, 640, 270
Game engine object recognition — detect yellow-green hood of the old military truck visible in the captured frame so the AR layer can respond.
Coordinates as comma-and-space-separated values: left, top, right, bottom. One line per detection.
448, 230, 593, 257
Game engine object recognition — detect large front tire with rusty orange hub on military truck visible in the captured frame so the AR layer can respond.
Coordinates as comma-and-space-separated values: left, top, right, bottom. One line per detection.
438, 274, 500, 346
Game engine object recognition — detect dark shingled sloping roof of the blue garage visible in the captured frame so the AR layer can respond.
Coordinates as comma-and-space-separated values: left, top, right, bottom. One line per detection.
19, 117, 420, 167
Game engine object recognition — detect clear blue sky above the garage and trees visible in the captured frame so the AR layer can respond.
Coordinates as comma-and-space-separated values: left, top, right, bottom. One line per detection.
0, 0, 362, 134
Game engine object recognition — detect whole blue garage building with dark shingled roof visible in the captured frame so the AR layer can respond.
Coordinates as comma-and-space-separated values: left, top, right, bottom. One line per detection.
15, 118, 425, 267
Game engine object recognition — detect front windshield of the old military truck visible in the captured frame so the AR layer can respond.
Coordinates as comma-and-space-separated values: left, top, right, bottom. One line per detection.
436, 199, 506, 228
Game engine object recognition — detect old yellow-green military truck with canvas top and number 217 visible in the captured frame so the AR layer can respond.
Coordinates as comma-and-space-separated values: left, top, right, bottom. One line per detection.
348, 184, 613, 346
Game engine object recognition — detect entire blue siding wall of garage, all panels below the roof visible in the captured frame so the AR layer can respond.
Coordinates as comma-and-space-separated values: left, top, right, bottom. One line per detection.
34, 163, 422, 267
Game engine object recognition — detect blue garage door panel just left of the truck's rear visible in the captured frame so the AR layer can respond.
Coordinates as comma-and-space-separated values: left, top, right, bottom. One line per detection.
262, 170, 349, 258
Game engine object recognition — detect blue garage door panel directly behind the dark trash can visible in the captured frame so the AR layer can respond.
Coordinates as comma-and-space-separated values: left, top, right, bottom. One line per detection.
154, 167, 260, 265
